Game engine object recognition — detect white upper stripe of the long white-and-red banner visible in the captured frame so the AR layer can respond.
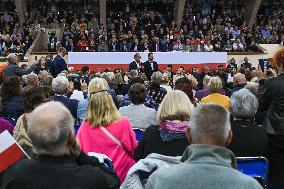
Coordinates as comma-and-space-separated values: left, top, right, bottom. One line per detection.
68, 52, 227, 65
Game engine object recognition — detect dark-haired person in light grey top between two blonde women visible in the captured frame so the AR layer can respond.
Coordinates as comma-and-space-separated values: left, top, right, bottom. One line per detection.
119, 83, 156, 129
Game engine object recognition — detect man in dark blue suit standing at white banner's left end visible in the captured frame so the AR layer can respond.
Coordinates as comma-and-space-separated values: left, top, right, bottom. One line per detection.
53, 47, 68, 77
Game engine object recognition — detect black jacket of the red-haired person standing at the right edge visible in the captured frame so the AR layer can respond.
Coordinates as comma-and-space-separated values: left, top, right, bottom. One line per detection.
259, 74, 284, 135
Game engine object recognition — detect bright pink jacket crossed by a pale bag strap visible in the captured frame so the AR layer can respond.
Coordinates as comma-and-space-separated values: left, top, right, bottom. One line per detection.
77, 118, 138, 183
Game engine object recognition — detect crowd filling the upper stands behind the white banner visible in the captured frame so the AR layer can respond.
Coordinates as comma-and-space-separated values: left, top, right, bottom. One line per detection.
0, 0, 284, 56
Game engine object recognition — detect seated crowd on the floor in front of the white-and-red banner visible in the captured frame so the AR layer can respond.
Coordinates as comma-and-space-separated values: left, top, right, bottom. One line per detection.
0, 45, 284, 188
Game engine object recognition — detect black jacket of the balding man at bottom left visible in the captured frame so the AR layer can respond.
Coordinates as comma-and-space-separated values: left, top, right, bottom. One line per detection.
2, 153, 119, 189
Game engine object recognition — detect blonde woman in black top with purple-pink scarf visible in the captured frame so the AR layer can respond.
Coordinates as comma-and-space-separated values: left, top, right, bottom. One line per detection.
135, 90, 194, 161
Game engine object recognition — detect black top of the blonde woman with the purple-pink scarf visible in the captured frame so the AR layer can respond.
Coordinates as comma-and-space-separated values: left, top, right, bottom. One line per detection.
135, 125, 189, 161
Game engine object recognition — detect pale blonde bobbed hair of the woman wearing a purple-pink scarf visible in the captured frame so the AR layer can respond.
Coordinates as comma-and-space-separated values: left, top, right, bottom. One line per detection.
157, 90, 194, 122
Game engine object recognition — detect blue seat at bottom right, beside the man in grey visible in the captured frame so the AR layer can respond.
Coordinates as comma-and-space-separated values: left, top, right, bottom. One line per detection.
237, 157, 269, 188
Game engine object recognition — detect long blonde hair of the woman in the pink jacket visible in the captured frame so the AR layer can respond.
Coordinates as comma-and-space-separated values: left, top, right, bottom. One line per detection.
86, 91, 121, 128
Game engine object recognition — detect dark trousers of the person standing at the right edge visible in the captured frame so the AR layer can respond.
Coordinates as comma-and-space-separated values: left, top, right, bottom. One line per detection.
267, 134, 284, 189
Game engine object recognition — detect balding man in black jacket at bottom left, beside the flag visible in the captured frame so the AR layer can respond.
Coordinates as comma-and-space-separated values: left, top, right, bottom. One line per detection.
2, 102, 119, 189
